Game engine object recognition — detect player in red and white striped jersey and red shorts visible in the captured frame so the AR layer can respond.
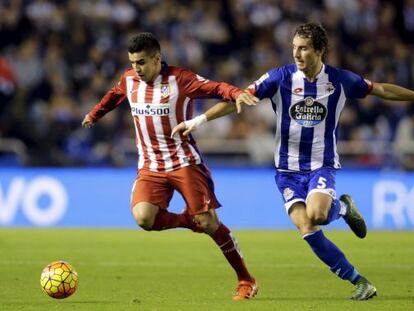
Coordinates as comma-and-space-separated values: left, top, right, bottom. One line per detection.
82, 33, 258, 300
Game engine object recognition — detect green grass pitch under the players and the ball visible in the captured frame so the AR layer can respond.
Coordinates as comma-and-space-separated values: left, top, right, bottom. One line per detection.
0, 229, 414, 311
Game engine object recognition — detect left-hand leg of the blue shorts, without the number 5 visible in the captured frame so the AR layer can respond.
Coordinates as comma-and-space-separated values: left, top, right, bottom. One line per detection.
275, 171, 308, 214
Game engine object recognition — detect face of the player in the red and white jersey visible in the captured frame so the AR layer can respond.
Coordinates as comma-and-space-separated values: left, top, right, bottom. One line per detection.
128, 51, 161, 82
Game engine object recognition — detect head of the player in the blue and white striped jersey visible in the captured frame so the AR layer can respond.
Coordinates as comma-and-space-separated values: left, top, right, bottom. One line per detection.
293, 23, 328, 72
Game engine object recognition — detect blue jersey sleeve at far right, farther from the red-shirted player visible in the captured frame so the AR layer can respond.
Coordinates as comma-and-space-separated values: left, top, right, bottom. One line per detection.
340, 69, 373, 98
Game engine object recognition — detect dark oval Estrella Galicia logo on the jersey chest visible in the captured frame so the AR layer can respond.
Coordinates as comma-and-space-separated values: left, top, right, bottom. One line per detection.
289, 96, 328, 127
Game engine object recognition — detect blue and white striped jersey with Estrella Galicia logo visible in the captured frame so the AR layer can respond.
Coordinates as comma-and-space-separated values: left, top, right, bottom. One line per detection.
249, 64, 372, 172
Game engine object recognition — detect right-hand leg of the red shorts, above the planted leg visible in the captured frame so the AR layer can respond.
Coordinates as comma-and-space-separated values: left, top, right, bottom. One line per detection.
169, 164, 221, 215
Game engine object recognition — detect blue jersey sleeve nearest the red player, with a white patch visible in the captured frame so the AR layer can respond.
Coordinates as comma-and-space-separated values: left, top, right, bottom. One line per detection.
247, 69, 282, 99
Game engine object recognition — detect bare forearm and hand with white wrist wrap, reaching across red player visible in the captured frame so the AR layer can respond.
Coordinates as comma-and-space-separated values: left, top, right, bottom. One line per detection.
171, 102, 238, 138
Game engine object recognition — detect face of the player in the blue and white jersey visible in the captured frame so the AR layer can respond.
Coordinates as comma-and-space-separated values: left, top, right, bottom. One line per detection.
293, 36, 323, 74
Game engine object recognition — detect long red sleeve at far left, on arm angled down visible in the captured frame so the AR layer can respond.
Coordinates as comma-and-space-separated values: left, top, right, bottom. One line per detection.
88, 74, 126, 122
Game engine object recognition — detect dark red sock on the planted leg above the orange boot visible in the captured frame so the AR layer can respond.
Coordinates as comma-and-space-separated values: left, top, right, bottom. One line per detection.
211, 224, 253, 281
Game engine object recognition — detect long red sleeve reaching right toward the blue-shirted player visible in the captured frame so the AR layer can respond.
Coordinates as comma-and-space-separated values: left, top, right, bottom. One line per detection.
178, 68, 244, 100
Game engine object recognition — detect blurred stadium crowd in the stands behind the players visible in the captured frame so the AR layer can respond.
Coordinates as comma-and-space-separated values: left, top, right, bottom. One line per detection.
0, 0, 414, 169
